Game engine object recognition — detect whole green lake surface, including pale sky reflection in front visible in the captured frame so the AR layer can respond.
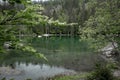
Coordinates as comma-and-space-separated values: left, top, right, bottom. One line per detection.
0, 37, 103, 80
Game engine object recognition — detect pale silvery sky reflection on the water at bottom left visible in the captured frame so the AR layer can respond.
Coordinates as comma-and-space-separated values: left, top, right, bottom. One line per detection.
0, 62, 76, 80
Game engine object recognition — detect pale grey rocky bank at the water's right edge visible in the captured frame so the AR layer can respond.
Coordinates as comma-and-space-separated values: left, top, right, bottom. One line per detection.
100, 42, 120, 77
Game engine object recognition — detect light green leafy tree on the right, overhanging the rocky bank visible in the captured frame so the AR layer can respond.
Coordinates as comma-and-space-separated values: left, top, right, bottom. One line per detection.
82, 0, 120, 50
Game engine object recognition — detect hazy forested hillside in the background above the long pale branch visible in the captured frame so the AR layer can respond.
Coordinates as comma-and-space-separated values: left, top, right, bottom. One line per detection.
41, 0, 97, 24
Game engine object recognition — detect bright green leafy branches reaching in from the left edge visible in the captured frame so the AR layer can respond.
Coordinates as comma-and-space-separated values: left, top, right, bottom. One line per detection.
0, 0, 47, 60
